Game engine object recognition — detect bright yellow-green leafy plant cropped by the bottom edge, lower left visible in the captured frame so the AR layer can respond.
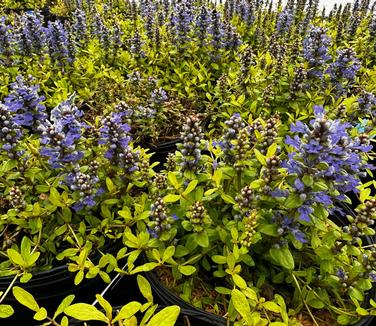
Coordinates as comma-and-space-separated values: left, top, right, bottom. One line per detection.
0, 275, 180, 326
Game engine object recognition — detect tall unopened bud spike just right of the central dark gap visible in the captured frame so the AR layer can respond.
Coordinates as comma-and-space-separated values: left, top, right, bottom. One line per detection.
178, 116, 203, 171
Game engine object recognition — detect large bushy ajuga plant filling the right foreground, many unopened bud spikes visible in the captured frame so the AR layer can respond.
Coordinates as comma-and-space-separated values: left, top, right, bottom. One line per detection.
121, 111, 376, 325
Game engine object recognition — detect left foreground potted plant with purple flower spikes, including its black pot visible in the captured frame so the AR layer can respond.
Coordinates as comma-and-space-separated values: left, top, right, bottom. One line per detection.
0, 76, 154, 318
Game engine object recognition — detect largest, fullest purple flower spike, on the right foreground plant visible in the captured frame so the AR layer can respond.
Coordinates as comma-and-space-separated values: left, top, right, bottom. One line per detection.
282, 106, 372, 221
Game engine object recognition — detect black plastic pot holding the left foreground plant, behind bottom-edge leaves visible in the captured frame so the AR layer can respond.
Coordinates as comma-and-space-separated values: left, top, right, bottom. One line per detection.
0, 239, 129, 326
